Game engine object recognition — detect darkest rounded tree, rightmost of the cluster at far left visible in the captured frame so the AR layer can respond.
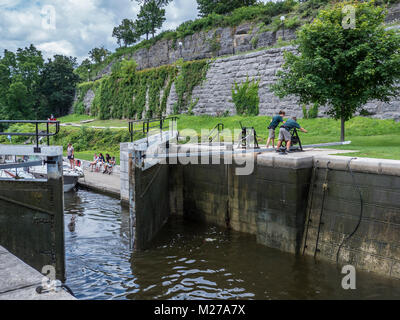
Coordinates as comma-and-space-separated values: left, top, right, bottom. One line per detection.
40, 55, 79, 117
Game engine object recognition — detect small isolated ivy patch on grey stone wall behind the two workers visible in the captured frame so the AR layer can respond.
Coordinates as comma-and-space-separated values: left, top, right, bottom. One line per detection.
232, 77, 260, 116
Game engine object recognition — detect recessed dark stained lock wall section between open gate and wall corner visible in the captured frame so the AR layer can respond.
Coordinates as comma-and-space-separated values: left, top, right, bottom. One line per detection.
170, 162, 311, 253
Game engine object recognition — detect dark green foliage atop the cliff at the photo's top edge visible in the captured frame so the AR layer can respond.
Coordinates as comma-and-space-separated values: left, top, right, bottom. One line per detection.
197, 0, 257, 17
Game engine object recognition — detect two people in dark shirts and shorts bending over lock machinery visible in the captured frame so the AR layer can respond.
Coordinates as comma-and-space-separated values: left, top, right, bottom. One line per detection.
267, 111, 308, 152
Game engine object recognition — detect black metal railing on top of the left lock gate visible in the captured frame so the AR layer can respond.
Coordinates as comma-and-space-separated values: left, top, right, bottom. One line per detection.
0, 120, 60, 153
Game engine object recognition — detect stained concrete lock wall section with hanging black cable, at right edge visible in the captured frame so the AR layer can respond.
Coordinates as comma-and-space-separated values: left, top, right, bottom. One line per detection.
304, 157, 400, 278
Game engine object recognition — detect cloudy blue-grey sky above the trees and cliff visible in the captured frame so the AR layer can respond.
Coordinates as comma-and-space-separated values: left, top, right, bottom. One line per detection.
0, 0, 272, 62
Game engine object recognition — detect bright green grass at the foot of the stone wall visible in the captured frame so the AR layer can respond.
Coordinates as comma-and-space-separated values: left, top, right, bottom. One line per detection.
60, 115, 400, 160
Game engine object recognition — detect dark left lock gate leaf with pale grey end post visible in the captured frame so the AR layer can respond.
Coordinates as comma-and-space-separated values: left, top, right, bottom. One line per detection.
0, 148, 65, 280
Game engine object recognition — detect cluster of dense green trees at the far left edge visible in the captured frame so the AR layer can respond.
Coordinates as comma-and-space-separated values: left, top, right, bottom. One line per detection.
0, 45, 79, 120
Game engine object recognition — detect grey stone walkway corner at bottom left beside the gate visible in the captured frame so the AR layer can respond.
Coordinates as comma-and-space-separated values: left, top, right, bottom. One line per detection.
0, 246, 76, 300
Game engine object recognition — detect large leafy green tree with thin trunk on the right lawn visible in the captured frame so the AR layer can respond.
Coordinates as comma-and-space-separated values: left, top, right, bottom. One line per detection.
272, 2, 400, 141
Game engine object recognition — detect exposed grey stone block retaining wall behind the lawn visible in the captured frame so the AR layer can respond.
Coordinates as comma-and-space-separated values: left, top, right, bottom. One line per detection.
167, 46, 400, 120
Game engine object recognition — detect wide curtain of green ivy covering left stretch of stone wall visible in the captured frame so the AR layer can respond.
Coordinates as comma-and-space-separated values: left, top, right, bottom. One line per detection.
74, 60, 208, 120
